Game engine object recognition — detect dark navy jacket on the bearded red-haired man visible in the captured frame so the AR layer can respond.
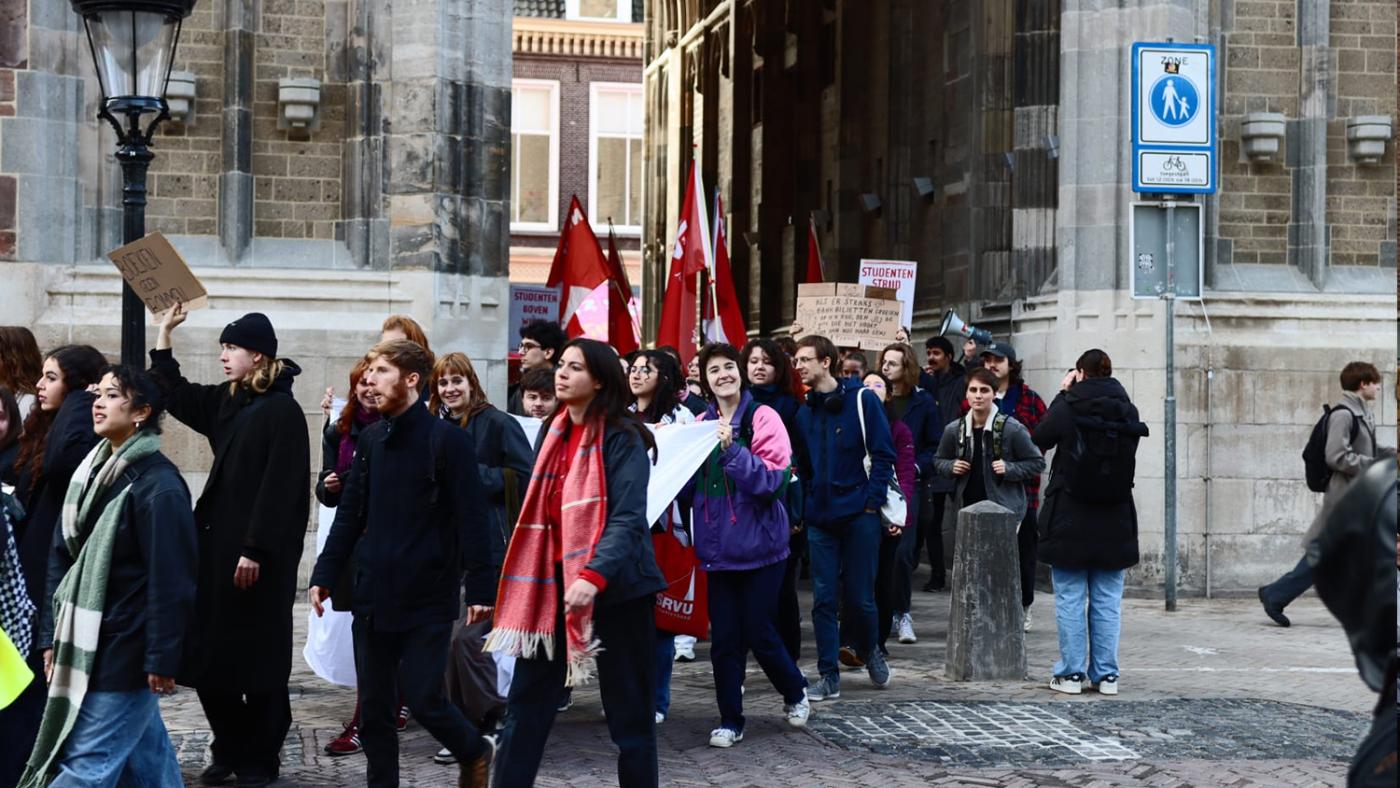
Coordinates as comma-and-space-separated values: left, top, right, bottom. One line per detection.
311, 404, 496, 630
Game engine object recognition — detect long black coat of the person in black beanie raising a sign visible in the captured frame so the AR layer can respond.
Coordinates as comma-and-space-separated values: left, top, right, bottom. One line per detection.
150, 350, 311, 693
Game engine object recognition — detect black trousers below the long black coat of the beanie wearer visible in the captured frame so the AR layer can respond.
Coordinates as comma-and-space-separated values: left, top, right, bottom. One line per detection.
196, 686, 291, 777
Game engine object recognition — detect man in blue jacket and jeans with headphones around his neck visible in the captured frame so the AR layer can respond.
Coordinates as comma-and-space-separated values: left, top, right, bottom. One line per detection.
795, 335, 895, 701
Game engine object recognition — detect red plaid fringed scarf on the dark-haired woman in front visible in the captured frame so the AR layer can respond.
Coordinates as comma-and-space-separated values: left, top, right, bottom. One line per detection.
486, 410, 608, 687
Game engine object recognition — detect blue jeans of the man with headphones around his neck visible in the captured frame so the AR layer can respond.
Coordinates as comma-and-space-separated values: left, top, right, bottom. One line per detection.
806, 514, 889, 676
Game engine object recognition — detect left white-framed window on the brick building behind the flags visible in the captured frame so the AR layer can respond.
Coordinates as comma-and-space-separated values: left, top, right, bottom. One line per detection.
511, 80, 559, 230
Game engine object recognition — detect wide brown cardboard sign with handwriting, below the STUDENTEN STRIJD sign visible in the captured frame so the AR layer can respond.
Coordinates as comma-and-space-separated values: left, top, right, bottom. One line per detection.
797, 283, 900, 350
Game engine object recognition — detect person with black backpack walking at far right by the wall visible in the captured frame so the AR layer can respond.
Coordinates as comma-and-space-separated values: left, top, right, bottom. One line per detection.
1259, 361, 1396, 627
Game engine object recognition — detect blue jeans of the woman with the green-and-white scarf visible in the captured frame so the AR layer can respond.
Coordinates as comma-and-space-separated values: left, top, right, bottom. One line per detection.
49, 689, 183, 788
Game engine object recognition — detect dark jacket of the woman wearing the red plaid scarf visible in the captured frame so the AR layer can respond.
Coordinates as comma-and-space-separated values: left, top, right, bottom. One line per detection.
535, 416, 666, 607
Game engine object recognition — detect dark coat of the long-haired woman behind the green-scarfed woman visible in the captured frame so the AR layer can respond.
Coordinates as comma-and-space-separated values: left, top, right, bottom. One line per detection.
15, 392, 99, 610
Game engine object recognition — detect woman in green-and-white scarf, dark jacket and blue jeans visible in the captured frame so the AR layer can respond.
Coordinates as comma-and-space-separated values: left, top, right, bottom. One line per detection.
21, 367, 199, 788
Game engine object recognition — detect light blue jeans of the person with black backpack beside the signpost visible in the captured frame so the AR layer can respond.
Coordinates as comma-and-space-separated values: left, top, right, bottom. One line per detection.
1050, 567, 1123, 683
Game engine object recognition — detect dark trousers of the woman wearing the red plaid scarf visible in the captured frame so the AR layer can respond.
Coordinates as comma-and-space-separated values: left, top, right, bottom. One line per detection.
495, 593, 658, 788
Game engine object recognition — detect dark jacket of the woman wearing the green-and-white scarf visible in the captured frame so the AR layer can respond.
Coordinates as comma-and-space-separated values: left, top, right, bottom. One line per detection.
35, 452, 199, 691
